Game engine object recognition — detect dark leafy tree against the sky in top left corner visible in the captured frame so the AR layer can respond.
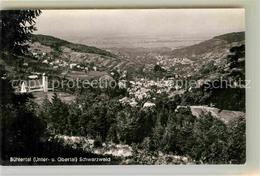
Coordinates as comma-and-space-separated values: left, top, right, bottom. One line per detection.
0, 10, 41, 55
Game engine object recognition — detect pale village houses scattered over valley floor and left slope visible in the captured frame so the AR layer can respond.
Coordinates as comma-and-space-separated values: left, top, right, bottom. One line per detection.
17, 47, 209, 107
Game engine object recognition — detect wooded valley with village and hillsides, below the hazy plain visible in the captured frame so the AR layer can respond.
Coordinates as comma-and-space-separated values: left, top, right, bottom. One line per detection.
3, 32, 245, 164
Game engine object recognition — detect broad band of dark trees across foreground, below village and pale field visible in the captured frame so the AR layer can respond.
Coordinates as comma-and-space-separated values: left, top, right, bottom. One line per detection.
38, 92, 246, 164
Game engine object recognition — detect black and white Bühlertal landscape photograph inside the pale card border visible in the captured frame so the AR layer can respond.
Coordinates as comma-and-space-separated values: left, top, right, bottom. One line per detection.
0, 8, 246, 166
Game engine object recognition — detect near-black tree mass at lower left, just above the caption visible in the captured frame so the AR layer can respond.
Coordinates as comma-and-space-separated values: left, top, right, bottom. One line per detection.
0, 79, 46, 161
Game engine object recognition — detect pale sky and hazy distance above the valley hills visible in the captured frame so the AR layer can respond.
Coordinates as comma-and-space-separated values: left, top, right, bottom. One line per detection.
36, 9, 245, 47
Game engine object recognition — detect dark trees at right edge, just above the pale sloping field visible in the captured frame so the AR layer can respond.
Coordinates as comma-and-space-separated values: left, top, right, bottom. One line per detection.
182, 45, 245, 111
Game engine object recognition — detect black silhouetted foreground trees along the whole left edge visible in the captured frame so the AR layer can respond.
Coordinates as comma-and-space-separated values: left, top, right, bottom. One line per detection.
0, 10, 45, 164
